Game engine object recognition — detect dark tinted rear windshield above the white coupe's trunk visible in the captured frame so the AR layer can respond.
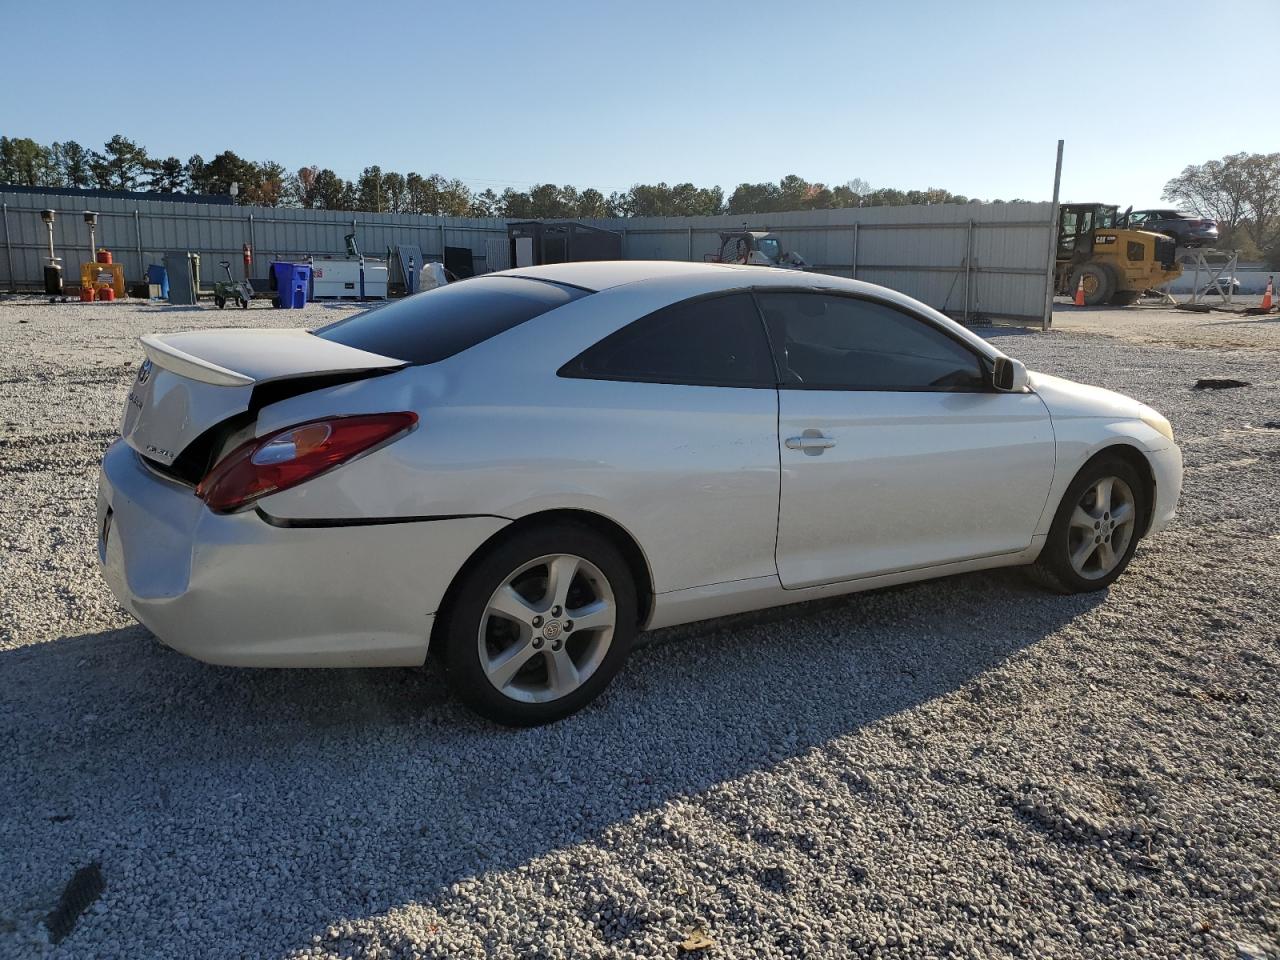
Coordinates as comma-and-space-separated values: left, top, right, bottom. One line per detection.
316, 276, 590, 364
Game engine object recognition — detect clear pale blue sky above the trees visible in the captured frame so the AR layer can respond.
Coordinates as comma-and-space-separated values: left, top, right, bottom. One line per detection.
0, 0, 1280, 206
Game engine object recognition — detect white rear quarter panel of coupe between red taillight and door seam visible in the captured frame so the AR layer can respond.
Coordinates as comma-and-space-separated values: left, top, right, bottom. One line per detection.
259, 273, 778, 593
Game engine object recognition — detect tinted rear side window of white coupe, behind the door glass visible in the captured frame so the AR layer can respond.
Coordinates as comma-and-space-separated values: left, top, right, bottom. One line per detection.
561, 293, 774, 387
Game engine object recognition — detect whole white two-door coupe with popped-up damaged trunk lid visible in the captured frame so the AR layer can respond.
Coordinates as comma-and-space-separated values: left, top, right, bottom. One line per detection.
99, 261, 1181, 724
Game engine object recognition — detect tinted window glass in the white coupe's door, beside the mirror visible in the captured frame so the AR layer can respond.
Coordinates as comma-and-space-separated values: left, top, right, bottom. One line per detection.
759, 293, 986, 390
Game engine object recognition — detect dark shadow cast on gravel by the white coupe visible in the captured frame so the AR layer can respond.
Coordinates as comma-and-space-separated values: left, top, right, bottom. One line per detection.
0, 571, 1105, 956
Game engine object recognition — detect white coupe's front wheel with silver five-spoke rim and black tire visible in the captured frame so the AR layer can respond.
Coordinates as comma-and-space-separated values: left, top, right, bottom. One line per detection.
1032, 454, 1147, 594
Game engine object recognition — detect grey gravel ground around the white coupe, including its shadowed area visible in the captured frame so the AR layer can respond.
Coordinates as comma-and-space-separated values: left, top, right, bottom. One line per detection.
0, 296, 1280, 959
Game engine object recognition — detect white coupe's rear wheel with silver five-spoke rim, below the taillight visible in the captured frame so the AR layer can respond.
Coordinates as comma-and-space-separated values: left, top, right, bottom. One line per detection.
444, 524, 637, 727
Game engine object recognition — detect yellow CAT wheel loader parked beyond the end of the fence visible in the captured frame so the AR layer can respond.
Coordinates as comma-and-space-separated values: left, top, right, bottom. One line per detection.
1056, 204, 1183, 307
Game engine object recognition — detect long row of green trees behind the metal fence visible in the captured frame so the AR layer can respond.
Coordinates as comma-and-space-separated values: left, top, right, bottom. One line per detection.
0, 133, 1000, 220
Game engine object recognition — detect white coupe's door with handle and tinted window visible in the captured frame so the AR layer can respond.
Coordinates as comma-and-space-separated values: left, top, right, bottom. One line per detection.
758, 292, 1055, 589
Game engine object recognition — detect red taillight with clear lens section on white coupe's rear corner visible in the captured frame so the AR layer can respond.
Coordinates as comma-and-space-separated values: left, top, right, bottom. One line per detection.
196, 412, 417, 513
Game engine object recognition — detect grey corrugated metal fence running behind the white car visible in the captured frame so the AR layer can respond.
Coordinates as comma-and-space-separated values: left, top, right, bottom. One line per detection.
0, 193, 1052, 323
